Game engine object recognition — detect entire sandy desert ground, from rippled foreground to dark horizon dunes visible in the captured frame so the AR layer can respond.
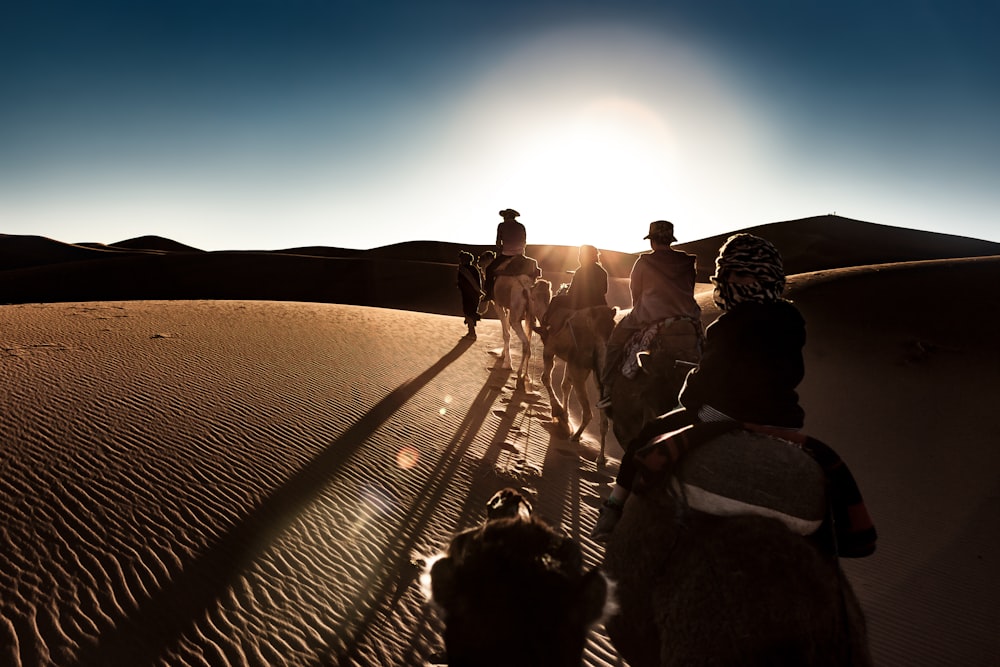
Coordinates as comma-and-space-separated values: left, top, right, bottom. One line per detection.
0, 216, 1000, 667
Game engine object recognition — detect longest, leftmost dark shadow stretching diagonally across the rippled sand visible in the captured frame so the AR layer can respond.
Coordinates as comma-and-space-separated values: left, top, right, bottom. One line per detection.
69, 340, 476, 667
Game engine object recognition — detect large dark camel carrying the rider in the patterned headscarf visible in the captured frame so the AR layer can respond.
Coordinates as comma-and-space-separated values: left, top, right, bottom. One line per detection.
603, 431, 871, 667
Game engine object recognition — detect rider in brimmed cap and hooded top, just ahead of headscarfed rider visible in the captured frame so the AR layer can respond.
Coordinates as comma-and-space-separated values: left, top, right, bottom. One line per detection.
597, 220, 701, 409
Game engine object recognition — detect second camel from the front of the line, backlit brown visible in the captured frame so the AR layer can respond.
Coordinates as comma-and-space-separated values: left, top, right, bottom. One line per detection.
542, 306, 615, 454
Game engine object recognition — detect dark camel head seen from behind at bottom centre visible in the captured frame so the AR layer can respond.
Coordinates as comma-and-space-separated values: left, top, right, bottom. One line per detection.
424, 489, 609, 667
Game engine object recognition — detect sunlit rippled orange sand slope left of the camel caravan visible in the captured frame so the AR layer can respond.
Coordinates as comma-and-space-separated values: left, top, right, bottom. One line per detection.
0, 302, 613, 666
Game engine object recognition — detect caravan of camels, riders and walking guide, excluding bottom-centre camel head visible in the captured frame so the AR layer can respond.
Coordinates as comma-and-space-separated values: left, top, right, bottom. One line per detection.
453, 209, 877, 666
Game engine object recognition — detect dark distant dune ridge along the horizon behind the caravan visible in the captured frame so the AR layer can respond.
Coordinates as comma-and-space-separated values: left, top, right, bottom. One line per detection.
0, 216, 1000, 315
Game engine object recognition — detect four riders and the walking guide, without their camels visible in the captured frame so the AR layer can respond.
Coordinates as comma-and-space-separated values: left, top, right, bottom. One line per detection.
459, 208, 875, 556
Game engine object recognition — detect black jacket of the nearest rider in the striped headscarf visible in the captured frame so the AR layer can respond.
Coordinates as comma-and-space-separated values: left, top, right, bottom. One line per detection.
680, 300, 806, 428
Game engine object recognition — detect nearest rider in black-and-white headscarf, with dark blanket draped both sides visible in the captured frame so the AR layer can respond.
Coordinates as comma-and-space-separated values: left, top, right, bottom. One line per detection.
591, 233, 876, 557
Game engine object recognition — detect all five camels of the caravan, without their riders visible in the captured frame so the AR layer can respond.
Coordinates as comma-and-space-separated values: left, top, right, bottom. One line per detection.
428, 268, 871, 667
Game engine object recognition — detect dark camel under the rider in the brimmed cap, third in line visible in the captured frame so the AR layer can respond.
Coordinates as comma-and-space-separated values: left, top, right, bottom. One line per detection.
601, 317, 704, 460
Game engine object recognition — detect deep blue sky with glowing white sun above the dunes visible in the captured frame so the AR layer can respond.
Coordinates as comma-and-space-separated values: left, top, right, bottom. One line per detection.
0, 0, 1000, 252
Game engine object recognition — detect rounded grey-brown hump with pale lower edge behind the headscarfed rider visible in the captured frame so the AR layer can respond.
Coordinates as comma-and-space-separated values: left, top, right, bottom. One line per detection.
674, 430, 827, 535
